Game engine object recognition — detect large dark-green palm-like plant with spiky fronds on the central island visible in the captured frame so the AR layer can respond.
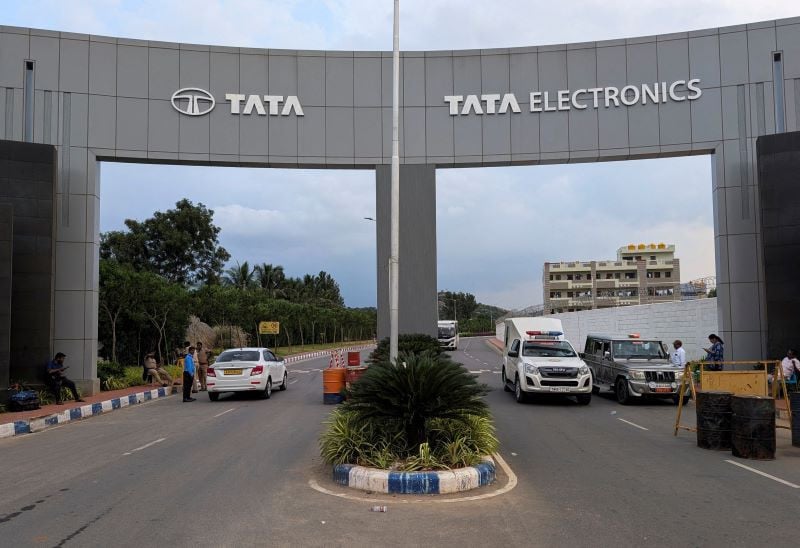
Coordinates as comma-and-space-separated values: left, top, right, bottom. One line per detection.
343, 351, 489, 451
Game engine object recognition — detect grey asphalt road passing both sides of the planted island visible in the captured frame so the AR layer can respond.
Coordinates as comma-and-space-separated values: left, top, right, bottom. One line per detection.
0, 339, 800, 547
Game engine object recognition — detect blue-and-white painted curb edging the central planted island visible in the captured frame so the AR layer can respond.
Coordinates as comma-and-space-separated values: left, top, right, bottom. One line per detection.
333, 457, 495, 495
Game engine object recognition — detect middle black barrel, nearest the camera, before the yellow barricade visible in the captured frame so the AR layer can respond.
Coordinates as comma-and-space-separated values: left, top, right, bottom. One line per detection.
731, 396, 775, 460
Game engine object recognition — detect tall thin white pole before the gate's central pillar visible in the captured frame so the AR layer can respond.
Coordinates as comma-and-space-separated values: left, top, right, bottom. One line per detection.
389, 0, 400, 363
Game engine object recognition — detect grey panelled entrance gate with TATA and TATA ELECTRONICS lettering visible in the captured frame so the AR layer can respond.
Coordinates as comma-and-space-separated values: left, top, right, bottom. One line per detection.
0, 18, 800, 390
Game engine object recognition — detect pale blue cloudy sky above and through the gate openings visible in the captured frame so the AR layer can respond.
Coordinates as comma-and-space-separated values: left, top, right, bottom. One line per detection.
0, 0, 800, 308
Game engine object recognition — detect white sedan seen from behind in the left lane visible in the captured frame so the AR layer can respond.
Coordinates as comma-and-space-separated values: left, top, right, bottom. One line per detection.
206, 348, 288, 401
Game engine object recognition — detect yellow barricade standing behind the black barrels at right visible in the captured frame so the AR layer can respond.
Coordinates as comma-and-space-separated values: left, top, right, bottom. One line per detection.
674, 360, 792, 436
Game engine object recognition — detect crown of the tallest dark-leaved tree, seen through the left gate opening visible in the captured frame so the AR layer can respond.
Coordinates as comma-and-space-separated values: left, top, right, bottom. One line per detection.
100, 199, 230, 284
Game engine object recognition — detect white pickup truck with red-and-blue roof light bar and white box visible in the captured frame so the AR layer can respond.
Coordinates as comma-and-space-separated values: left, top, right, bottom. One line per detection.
502, 317, 592, 405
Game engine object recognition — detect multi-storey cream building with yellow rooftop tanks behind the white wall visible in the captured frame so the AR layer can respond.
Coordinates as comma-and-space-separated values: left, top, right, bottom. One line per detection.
542, 243, 681, 314
